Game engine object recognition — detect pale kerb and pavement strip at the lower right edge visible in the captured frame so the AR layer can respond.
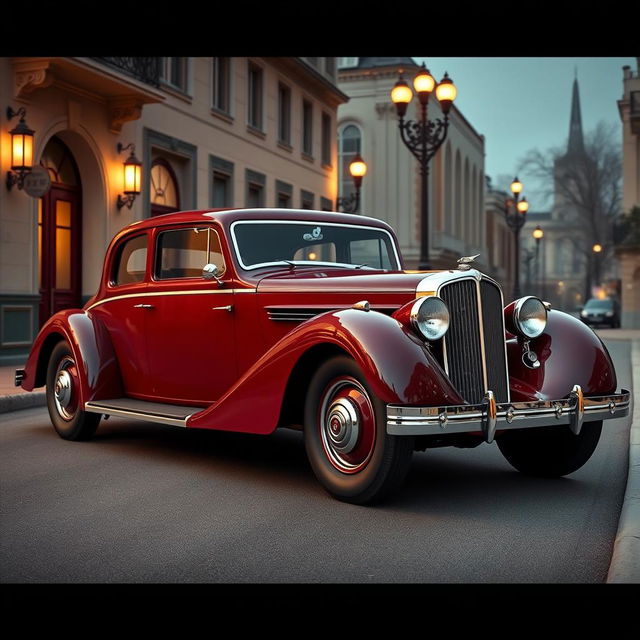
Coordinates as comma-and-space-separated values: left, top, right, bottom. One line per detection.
607, 340, 640, 584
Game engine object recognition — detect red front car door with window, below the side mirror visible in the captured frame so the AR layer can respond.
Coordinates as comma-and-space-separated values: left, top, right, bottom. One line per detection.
146, 226, 237, 404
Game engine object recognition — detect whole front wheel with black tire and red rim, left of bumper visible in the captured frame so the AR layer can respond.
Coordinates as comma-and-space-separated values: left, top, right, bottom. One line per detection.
304, 356, 414, 504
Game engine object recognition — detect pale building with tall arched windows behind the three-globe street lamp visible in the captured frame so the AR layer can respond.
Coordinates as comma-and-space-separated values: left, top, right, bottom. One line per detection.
338, 58, 484, 273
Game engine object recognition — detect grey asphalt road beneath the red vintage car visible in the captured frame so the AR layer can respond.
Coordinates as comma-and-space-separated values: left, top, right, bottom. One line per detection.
0, 341, 631, 583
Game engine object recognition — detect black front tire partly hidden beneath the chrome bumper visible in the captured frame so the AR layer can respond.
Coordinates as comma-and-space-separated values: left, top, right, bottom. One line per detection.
496, 420, 602, 478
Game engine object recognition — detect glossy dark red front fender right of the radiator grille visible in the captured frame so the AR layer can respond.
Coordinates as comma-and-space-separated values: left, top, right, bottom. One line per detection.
507, 310, 617, 401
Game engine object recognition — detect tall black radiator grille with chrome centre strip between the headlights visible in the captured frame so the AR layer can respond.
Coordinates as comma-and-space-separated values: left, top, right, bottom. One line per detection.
438, 278, 509, 404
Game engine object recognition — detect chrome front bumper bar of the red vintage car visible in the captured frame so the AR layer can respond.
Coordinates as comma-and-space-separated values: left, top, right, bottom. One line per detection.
387, 385, 630, 442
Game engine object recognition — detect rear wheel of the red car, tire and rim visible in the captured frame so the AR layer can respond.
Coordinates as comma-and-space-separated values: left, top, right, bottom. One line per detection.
47, 342, 102, 440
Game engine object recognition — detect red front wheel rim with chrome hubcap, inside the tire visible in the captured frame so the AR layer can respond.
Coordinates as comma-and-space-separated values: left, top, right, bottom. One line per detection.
318, 376, 376, 473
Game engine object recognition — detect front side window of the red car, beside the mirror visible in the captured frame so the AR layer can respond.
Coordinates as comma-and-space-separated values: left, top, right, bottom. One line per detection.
154, 227, 225, 280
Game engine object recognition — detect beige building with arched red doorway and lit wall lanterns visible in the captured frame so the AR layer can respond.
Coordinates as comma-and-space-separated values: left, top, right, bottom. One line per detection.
0, 57, 347, 364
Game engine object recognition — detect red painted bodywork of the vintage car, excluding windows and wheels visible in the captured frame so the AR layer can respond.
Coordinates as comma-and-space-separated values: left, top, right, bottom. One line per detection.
22, 209, 616, 434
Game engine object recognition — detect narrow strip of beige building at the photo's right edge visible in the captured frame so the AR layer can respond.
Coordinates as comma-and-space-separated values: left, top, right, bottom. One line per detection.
616, 58, 640, 329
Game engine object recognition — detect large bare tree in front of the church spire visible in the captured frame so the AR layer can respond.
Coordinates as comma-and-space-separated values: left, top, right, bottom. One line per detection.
519, 122, 622, 298
